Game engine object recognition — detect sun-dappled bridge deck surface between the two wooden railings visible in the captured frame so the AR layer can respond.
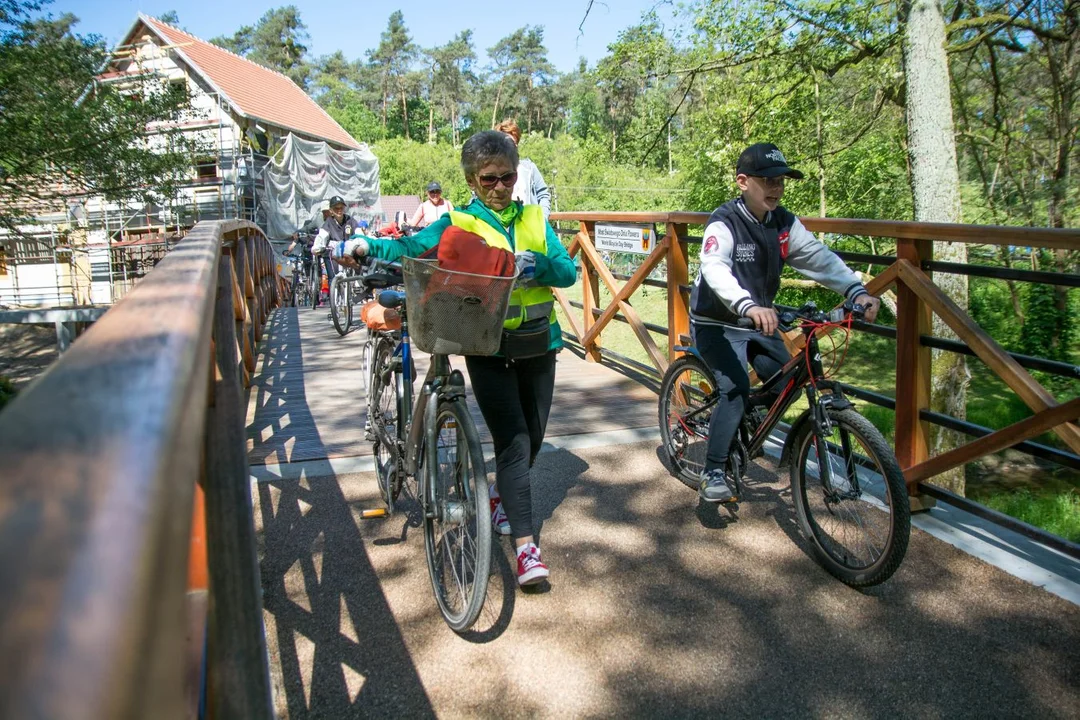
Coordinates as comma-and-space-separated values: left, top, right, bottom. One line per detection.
248, 310, 1080, 719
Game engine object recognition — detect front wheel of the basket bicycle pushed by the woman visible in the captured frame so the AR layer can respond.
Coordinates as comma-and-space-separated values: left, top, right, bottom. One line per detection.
421, 399, 491, 633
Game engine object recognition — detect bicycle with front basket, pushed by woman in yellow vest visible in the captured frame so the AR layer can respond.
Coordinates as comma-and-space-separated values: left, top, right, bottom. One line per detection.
369, 253, 515, 633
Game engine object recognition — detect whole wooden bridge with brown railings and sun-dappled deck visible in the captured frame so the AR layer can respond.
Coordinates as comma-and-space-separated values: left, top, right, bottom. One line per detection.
0, 213, 1080, 718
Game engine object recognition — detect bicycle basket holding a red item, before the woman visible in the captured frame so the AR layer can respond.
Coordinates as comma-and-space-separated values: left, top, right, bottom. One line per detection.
402, 258, 516, 355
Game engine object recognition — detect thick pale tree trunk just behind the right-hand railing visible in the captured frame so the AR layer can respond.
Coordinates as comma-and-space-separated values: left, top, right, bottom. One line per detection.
900, 0, 971, 495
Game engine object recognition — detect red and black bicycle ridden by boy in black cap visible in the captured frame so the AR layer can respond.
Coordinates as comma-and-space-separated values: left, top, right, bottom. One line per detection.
659, 302, 910, 587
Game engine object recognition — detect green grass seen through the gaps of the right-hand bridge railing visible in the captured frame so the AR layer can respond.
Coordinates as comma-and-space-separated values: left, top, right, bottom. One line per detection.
558, 283, 1080, 540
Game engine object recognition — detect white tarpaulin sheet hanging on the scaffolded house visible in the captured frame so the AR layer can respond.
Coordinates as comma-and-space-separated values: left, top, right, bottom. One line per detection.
259, 133, 382, 240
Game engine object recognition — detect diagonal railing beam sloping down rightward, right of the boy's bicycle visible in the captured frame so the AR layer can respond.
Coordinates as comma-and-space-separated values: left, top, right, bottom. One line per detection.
896, 260, 1080, 452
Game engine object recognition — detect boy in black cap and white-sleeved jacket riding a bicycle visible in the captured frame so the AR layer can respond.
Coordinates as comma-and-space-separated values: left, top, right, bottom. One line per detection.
690, 142, 881, 502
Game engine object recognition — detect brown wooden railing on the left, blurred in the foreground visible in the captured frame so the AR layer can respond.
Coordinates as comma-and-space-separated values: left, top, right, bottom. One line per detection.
0, 221, 283, 719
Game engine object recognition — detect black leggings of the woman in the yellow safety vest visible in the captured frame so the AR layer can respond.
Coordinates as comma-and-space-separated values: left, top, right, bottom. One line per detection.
465, 350, 555, 538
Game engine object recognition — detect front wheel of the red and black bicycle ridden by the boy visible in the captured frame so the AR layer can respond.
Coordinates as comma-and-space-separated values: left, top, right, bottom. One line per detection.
791, 408, 912, 587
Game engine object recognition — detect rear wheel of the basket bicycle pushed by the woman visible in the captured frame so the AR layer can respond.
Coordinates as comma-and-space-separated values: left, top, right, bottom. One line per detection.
367, 337, 404, 513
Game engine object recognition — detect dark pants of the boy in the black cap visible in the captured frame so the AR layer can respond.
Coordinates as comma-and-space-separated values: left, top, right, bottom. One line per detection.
690, 323, 791, 471
